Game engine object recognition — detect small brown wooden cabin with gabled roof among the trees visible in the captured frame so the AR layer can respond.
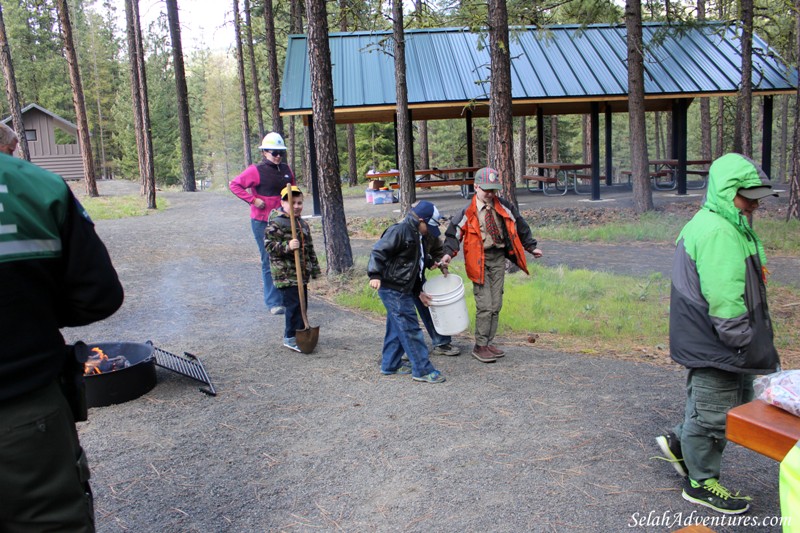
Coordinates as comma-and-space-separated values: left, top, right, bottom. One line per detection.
2, 104, 85, 180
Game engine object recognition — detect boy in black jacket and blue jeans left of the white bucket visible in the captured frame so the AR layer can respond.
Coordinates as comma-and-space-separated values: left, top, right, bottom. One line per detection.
367, 200, 450, 383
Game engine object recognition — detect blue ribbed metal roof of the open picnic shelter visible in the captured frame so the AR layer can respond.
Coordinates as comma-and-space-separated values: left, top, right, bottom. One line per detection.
280, 22, 797, 123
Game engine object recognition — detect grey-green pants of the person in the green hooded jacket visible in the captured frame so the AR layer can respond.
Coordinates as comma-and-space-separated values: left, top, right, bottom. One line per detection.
675, 368, 753, 481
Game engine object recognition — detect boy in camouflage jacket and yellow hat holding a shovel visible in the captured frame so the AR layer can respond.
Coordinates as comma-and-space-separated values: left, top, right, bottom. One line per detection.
264, 185, 320, 352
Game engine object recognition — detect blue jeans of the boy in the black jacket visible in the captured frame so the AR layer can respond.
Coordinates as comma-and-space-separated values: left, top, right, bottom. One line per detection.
378, 288, 436, 378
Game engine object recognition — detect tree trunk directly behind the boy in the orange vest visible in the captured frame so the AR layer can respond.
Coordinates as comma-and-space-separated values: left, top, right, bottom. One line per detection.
489, 0, 517, 205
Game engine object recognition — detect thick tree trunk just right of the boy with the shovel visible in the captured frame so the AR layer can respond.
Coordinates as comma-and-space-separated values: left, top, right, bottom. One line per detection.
306, 0, 353, 274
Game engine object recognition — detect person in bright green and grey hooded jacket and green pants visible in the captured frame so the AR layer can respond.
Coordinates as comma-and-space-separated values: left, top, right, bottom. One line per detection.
656, 153, 779, 514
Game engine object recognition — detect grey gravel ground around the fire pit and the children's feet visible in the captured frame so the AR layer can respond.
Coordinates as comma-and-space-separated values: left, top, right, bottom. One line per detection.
65, 182, 780, 532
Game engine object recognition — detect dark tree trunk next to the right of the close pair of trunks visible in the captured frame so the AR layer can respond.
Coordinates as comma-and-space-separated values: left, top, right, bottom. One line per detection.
167, 0, 196, 192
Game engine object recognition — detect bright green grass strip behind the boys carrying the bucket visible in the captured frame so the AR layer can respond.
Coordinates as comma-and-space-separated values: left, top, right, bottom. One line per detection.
312, 258, 800, 369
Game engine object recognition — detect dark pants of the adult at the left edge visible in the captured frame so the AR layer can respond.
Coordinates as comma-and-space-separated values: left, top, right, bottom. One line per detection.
0, 382, 94, 532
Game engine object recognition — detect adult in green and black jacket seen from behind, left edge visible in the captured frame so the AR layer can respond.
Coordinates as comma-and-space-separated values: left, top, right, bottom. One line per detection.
0, 154, 123, 531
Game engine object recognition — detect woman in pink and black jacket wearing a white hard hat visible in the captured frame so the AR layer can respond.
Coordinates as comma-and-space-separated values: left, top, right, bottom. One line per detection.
230, 132, 295, 315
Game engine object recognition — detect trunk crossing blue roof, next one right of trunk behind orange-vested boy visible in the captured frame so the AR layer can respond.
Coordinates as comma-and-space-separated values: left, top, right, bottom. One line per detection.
625, 0, 653, 213
